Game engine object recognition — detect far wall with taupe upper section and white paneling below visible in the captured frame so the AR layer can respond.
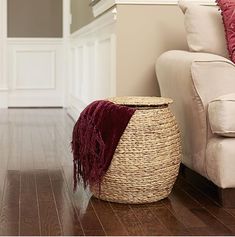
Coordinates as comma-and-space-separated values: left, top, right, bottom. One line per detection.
0, 0, 69, 107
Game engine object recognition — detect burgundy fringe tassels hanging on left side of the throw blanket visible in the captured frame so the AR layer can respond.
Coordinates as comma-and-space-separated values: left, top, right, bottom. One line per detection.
71, 112, 105, 191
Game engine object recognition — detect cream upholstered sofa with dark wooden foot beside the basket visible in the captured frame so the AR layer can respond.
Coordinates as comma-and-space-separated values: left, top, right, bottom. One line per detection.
156, 3, 235, 206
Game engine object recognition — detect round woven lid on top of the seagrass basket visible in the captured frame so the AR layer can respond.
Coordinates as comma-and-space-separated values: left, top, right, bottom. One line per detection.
107, 96, 173, 106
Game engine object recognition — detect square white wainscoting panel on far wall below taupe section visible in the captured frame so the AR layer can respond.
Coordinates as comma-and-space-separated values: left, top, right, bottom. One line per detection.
7, 39, 65, 107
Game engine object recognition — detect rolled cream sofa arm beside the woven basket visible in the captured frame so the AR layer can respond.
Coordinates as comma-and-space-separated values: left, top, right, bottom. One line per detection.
156, 50, 235, 177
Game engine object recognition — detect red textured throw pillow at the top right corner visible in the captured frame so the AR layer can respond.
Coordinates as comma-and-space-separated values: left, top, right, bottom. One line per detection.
216, 0, 235, 63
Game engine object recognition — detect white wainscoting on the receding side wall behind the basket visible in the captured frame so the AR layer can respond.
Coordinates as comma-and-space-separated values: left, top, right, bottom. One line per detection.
68, 11, 116, 120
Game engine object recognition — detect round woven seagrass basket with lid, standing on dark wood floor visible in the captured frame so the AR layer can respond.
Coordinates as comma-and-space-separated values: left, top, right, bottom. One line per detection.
92, 97, 181, 203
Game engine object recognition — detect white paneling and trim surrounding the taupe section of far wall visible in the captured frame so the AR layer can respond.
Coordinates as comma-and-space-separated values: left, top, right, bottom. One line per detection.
0, 0, 71, 108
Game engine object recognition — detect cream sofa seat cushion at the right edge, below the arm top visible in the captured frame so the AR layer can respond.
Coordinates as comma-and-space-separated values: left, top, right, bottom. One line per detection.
208, 94, 235, 137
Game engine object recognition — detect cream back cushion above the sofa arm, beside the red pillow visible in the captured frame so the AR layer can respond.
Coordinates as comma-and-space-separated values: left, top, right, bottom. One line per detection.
179, 0, 228, 58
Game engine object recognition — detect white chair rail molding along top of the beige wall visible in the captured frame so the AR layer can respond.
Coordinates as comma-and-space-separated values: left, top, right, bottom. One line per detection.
92, 0, 215, 17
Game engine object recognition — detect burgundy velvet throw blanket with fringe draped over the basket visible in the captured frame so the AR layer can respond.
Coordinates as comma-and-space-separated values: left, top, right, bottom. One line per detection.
72, 100, 135, 189
